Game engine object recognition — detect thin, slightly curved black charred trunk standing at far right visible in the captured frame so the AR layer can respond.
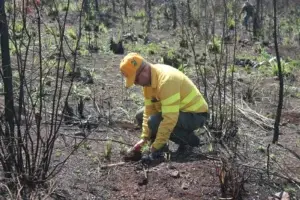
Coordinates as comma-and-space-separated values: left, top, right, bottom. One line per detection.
273, 0, 283, 144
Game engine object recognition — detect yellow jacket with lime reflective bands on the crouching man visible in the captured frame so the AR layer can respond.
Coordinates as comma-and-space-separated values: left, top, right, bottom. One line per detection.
141, 64, 208, 149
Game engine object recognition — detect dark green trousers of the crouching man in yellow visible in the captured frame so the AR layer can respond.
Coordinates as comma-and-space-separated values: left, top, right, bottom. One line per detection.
136, 108, 208, 147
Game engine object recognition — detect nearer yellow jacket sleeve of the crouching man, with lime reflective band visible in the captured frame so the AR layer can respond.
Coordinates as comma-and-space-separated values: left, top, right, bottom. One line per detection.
152, 80, 180, 149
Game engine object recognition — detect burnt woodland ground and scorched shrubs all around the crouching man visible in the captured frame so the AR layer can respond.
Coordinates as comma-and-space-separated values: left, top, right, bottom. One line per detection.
0, 0, 300, 200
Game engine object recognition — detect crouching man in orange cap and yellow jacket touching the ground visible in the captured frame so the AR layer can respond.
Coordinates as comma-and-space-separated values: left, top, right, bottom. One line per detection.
120, 53, 208, 162
